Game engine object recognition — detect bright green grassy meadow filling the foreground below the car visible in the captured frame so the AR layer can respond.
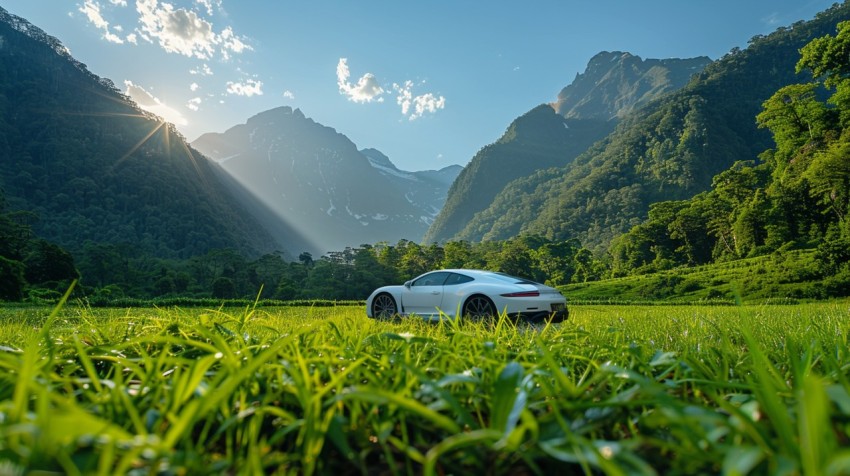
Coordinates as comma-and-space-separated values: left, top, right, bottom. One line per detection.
0, 301, 850, 475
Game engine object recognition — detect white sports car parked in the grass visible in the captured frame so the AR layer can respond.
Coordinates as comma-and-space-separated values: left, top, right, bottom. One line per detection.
366, 269, 569, 322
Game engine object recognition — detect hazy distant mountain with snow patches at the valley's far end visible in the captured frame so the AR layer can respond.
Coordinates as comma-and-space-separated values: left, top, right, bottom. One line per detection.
192, 107, 460, 254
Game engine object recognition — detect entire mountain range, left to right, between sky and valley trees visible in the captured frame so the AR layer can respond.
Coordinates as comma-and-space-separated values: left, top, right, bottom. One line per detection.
0, 0, 850, 268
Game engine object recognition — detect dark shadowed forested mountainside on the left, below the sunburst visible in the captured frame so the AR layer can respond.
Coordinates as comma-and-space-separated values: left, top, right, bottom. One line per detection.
0, 9, 276, 257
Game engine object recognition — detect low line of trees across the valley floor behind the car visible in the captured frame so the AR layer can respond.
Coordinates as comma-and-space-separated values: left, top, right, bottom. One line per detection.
0, 201, 606, 302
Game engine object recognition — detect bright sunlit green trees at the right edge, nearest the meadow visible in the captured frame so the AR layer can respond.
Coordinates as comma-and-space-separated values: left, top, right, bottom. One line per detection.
612, 17, 850, 295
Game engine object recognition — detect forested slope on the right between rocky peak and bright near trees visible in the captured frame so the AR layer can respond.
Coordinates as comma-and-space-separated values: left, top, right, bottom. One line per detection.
455, 4, 850, 252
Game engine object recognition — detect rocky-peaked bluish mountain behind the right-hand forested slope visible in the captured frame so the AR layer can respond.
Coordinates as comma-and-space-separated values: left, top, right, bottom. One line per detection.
425, 51, 709, 241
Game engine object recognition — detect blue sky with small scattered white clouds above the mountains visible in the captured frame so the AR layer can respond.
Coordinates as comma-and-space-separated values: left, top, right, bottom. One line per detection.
2, 0, 833, 170
